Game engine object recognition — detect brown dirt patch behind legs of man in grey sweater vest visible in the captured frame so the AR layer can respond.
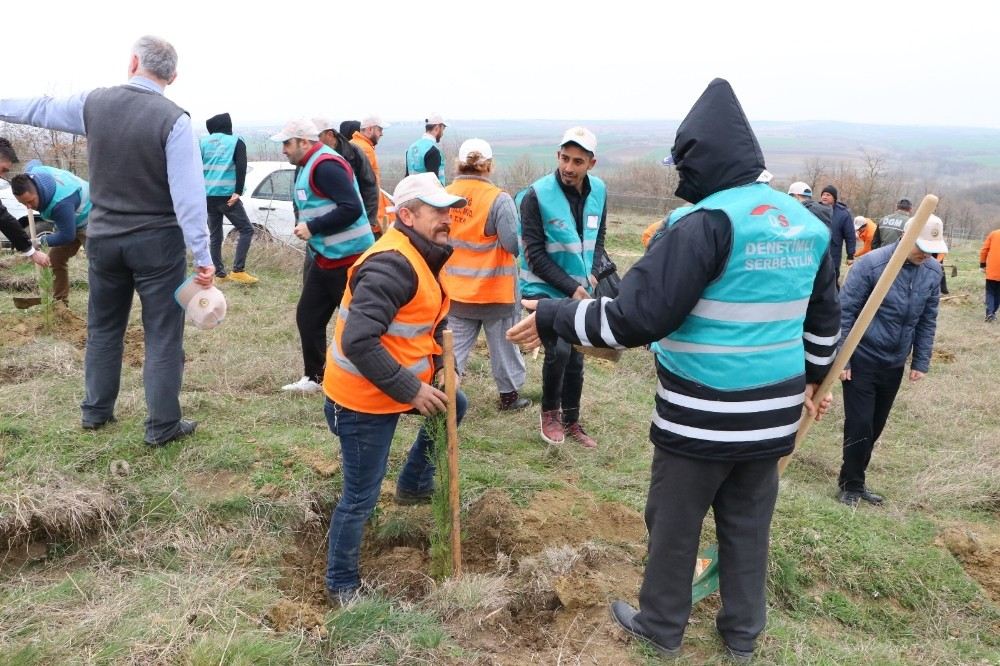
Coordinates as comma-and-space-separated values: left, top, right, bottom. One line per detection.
0, 302, 145, 368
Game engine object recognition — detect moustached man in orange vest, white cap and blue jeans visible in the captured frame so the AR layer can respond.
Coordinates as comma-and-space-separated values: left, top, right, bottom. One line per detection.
323, 173, 467, 607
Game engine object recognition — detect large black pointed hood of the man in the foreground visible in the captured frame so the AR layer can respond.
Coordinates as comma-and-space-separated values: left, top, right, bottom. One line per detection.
670, 79, 765, 203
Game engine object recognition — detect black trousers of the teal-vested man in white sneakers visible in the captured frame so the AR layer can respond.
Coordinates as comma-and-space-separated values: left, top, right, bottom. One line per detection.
295, 258, 349, 384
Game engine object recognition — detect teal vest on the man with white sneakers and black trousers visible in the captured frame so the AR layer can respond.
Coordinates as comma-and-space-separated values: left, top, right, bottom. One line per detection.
295, 145, 375, 259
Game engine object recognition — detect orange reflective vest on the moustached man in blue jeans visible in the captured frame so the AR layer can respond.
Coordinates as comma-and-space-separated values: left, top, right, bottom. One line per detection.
323, 228, 450, 414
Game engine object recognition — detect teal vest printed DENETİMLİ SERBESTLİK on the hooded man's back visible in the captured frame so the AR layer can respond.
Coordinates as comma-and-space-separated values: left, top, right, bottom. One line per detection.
652, 183, 830, 391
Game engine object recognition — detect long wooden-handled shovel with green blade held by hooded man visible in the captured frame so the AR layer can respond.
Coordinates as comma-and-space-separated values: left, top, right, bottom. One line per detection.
691, 194, 938, 604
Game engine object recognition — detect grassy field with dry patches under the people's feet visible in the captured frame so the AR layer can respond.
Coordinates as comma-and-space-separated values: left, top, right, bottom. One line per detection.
0, 215, 1000, 665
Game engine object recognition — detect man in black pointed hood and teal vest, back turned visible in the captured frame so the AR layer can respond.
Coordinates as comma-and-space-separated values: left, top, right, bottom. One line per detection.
508, 79, 840, 663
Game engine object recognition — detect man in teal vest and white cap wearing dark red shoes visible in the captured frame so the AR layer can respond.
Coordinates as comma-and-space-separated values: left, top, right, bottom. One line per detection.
517, 127, 608, 449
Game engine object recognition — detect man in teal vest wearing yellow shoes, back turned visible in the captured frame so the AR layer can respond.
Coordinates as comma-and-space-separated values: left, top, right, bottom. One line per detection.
199, 113, 257, 284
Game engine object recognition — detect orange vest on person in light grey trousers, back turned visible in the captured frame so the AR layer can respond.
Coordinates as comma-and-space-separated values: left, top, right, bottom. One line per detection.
441, 178, 517, 304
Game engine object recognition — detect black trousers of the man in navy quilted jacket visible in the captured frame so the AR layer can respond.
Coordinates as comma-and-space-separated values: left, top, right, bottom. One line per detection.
837, 359, 903, 492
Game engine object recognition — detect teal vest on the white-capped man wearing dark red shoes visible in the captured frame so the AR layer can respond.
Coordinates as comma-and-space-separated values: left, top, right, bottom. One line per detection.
516, 173, 607, 298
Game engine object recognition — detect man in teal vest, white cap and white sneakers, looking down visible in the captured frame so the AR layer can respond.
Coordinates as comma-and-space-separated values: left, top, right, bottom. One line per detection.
271, 118, 375, 394
